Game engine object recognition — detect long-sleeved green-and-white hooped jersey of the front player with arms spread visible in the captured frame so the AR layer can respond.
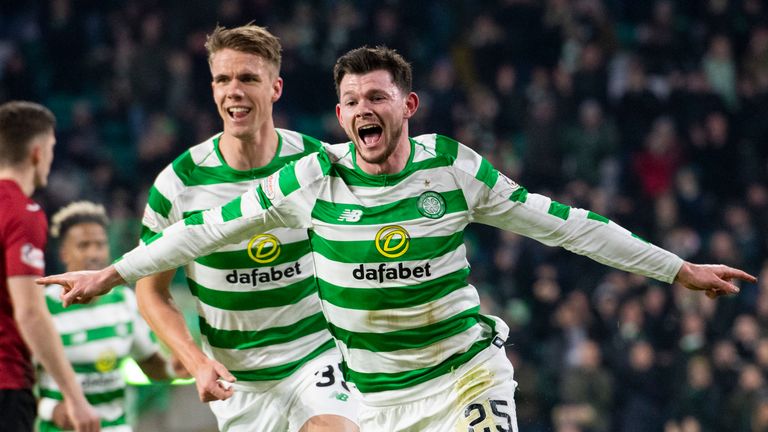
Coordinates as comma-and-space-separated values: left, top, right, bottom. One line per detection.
116, 134, 682, 405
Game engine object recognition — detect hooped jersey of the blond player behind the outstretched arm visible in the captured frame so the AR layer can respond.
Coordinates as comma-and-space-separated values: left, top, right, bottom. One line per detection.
142, 129, 334, 384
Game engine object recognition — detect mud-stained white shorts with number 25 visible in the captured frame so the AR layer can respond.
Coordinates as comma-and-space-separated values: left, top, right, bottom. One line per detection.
360, 346, 517, 432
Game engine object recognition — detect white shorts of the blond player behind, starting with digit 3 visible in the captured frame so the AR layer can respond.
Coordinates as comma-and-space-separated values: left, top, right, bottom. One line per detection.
209, 352, 359, 432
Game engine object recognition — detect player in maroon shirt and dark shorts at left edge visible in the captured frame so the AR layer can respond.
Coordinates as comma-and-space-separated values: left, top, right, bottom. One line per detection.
0, 101, 99, 432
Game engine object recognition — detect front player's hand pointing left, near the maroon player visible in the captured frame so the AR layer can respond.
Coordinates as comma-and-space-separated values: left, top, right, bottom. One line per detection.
35, 266, 125, 307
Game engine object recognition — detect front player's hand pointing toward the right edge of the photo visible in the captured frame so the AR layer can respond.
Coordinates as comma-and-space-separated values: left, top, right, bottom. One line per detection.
675, 261, 757, 298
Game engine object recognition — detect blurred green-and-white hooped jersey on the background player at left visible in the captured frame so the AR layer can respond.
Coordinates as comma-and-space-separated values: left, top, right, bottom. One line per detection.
38, 285, 158, 432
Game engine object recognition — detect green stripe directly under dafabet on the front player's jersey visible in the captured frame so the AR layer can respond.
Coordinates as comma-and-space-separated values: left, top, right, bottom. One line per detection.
317, 267, 469, 311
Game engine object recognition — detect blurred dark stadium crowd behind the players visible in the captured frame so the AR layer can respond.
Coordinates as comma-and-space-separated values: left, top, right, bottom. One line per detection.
0, 0, 768, 432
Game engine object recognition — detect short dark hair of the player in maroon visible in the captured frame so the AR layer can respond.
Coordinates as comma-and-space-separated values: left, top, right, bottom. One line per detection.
0, 101, 56, 166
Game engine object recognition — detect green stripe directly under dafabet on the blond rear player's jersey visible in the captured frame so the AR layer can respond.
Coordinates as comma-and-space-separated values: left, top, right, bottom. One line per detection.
187, 277, 317, 311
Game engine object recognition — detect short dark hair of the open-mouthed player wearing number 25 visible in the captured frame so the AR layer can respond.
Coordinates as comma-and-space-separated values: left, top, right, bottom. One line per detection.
333, 46, 413, 97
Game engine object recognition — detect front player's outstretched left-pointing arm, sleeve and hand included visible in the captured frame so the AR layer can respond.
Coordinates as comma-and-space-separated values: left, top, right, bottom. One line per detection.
37, 152, 331, 306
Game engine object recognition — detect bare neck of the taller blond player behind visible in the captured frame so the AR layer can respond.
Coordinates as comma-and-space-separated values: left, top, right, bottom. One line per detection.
219, 127, 278, 171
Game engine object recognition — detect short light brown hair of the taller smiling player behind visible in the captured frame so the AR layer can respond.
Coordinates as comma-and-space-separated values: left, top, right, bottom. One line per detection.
205, 23, 282, 73
